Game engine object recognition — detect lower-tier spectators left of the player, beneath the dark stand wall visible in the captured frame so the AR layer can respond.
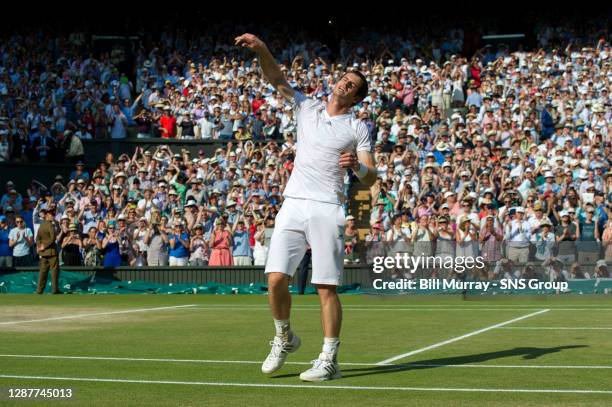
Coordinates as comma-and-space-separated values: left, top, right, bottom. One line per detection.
0, 140, 288, 267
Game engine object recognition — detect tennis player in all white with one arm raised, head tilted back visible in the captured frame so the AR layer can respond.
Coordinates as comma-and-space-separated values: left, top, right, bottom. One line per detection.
236, 34, 376, 381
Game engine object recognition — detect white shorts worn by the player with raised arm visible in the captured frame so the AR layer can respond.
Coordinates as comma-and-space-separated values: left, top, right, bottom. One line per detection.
266, 197, 345, 285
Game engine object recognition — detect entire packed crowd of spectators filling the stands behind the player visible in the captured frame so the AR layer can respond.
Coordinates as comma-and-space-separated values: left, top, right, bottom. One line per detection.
0, 20, 612, 278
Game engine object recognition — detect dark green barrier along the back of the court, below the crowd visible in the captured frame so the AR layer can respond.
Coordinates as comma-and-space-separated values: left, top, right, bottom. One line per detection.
0, 267, 612, 296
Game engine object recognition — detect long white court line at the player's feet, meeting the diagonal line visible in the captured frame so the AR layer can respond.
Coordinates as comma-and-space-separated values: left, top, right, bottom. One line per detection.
0, 354, 612, 369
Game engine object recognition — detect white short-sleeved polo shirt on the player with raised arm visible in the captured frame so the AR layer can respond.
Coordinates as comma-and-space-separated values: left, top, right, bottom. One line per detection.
283, 92, 371, 204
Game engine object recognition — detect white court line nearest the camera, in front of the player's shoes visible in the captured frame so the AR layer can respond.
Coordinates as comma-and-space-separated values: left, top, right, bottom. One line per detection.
0, 374, 612, 394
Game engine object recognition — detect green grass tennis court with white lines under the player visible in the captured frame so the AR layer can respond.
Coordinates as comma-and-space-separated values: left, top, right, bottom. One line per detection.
0, 295, 612, 406
